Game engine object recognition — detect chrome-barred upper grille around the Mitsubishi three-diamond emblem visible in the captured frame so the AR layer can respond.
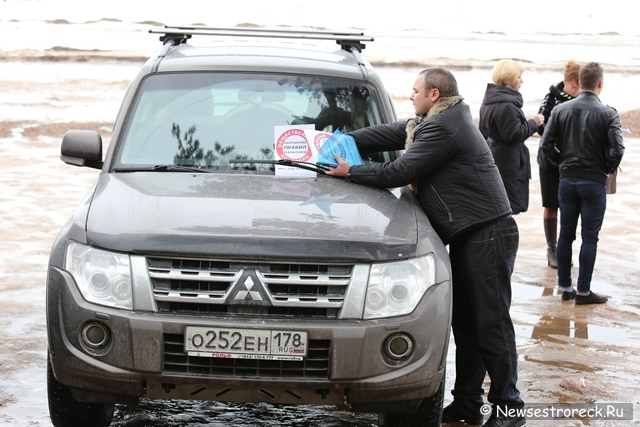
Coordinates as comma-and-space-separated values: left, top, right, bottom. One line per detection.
147, 258, 353, 318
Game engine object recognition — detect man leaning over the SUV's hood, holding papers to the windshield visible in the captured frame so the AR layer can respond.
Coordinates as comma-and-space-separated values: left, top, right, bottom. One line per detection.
327, 68, 525, 427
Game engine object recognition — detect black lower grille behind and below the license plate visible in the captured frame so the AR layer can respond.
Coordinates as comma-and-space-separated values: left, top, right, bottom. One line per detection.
164, 334, 331, 379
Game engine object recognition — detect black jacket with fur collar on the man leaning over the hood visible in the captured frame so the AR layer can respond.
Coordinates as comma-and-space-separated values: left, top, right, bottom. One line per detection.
349, 97, 511, 244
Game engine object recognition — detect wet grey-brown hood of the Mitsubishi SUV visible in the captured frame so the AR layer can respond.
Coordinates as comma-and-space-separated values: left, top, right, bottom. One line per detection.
86, 172, 419, 260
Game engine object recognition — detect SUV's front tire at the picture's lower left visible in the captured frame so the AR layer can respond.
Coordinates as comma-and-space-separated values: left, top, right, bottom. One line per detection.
47, 356, 115, 427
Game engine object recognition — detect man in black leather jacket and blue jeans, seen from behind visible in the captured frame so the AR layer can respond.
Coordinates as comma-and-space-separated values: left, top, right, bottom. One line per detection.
540, 62, 624, 304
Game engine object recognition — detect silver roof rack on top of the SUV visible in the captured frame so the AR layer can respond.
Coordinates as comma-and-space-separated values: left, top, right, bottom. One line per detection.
149, 25, 373, 79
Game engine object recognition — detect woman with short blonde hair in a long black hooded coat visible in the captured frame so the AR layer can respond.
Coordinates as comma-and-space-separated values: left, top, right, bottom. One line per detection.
480, 59, 544, 215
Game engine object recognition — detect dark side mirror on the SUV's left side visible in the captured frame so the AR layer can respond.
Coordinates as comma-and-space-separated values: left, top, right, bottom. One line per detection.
60, 130, 104, 169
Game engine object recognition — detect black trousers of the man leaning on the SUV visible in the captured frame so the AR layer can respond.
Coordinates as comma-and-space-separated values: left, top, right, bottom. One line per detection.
449, 216, 524, 413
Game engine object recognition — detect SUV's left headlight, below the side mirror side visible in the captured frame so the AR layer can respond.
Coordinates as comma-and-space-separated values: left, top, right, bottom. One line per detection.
65, 242, 133, 310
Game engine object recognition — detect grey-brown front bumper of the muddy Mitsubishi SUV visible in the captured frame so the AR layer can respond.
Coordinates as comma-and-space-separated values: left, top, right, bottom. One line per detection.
47, 267, 451, 405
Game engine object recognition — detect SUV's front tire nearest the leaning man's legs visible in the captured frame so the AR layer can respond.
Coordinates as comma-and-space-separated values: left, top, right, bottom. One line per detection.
378, 372, 446, 427
